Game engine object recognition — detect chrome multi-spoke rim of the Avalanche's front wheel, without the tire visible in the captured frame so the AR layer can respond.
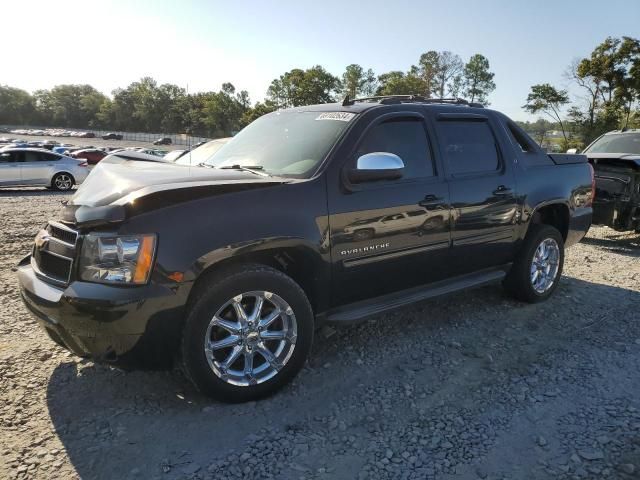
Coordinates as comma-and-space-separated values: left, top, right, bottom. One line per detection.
204, 291, 297, 386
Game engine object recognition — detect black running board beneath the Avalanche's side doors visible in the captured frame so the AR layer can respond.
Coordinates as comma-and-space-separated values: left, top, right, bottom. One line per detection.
325, 265, 511, 323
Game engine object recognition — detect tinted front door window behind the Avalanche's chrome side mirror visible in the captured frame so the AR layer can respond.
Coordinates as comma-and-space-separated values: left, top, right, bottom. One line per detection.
356, 118, 434, 179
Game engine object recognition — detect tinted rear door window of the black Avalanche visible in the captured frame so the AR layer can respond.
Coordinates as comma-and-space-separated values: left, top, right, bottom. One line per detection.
436, 120, 500, 175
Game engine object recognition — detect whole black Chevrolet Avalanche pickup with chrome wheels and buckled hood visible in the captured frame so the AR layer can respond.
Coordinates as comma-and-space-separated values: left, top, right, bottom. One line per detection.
18, 96, 593, 401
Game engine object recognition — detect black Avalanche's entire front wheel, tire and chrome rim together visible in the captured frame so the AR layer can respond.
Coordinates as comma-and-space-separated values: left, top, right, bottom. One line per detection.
182, 265, 313, 402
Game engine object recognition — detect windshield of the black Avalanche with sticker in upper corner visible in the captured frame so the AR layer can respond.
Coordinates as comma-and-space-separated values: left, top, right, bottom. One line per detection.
205, 111, 355, 178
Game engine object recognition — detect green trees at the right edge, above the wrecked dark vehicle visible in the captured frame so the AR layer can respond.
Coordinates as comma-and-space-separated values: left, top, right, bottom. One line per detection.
523, 37, 640, 149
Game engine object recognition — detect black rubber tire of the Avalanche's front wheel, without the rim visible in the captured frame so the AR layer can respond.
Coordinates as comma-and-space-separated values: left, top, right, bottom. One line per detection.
181, 265, 314, 403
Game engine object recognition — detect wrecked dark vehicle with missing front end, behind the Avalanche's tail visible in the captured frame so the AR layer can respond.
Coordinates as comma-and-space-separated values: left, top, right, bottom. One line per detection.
583, 129, 640, 233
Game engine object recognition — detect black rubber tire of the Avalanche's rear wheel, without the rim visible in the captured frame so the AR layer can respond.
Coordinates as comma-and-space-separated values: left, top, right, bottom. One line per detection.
503, 224, 564, 303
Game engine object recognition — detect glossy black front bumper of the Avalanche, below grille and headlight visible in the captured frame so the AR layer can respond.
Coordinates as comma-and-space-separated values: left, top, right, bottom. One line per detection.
18, 257, 186, 365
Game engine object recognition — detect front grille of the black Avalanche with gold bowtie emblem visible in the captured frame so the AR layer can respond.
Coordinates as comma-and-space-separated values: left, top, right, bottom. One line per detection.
32, 222, 78, 285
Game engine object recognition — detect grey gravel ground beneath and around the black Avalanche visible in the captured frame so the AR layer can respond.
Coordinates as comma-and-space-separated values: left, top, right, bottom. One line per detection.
0, 190, 640, 479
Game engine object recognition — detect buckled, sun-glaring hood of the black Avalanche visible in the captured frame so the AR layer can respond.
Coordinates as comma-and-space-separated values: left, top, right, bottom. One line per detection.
62, 155, 289, 227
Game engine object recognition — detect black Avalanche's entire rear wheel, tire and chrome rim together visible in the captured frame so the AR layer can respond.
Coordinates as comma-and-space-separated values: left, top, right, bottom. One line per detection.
504, 224, 564, 303
